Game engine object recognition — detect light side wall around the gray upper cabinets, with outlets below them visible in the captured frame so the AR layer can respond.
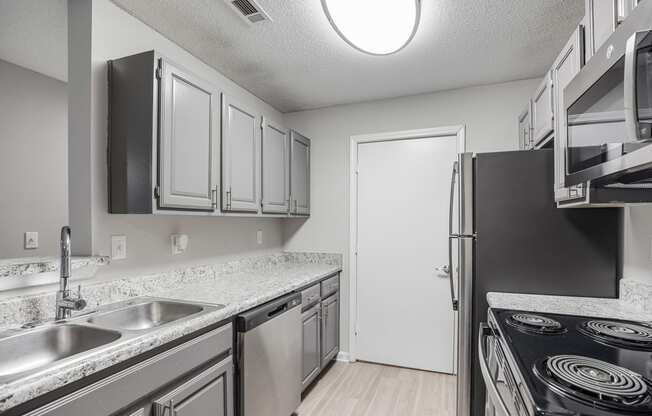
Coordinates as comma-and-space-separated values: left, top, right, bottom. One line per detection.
70, 0, 283, 274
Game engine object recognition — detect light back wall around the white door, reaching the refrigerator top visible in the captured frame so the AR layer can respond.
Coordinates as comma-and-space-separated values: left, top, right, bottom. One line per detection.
285, 79, 539, 351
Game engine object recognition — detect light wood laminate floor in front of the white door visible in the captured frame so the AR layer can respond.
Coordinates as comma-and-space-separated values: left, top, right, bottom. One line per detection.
297, 362, 456, 416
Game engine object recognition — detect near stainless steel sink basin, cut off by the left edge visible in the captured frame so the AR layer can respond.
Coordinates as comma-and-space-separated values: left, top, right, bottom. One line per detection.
0, 324, 121, 378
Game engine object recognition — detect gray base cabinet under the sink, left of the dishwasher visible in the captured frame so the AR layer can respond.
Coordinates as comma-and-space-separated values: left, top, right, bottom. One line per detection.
27, 324, 234, 416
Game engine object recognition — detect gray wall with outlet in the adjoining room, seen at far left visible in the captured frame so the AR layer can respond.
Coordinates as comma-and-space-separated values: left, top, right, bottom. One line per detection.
0, 60, 68, 258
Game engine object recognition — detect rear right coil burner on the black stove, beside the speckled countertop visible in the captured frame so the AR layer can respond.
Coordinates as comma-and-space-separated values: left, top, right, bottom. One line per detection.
579, 320, 652, 351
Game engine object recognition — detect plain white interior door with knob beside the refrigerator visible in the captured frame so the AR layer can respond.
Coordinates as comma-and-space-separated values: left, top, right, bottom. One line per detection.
356, 136, 458, 373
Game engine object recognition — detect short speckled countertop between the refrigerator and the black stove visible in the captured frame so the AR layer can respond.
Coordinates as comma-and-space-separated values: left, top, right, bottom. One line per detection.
487, 279, 652, 321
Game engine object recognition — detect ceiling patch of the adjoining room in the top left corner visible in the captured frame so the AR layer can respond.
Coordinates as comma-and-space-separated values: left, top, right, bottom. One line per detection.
0, 0, 68, 81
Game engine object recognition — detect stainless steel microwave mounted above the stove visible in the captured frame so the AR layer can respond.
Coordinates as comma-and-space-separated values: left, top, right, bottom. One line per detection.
563, 1, 652, 188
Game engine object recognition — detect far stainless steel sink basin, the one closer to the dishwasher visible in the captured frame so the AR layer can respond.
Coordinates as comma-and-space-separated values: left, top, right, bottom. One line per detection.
88, 300, 204, 331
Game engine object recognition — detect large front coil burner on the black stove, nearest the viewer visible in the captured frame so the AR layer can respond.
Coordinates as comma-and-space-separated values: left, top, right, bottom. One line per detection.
535, 355, 652, 414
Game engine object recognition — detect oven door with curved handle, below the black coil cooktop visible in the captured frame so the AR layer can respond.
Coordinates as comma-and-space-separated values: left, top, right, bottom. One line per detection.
478, 324, 527, 416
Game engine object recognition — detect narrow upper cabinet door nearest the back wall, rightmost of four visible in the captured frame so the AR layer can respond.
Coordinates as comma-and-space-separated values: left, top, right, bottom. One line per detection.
290, 131, 310, 215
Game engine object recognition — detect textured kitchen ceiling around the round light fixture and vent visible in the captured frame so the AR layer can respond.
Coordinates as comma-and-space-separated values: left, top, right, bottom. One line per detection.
112, 0, 584, 112
